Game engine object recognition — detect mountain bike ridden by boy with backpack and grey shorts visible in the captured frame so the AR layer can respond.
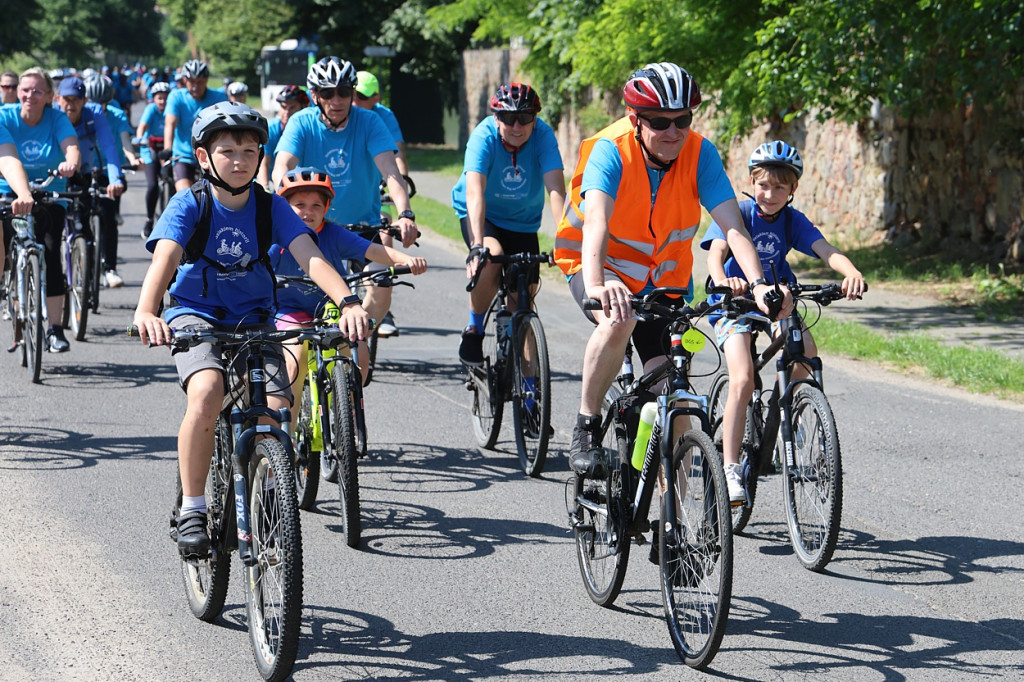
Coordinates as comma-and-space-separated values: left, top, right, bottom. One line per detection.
128, 327, 315, 681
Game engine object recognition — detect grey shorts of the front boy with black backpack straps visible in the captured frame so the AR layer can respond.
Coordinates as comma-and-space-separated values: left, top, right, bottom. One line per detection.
170, 315, 292, 404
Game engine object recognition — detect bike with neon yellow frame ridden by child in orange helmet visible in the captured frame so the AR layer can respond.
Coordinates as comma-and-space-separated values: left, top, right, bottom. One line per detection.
276, 266, 413, 547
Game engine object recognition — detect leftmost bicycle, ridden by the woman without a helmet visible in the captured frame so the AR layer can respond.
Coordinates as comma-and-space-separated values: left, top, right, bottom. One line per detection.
0, 171, 75, 384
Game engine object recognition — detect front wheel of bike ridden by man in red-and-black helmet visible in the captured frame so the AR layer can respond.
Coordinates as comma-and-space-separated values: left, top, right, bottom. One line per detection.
512, 313, 551, 478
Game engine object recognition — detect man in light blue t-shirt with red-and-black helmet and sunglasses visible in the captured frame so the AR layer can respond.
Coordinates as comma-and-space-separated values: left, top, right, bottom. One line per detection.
452, 83, 565, 366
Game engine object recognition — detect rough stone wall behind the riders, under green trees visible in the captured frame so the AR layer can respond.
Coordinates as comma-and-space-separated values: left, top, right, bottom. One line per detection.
460, 49, 1024, 263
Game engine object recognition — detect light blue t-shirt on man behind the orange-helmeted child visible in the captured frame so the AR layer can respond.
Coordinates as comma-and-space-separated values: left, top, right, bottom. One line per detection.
276, 105, 398, 224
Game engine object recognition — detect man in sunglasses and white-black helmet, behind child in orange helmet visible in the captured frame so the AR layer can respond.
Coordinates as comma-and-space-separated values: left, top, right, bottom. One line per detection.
272, 56, 418, 346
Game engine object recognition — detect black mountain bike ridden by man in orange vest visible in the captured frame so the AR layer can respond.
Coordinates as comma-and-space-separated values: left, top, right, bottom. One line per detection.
565, 288, 732, 668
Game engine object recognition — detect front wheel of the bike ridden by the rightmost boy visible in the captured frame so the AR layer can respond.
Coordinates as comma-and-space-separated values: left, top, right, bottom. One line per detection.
782, 385, 843, 571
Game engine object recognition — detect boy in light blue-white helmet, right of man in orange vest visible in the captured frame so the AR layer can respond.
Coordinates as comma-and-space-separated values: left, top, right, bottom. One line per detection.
700, 141, 867, 505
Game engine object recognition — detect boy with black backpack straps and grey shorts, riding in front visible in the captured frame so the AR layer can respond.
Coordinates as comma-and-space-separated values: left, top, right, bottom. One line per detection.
134, 102, 369, 558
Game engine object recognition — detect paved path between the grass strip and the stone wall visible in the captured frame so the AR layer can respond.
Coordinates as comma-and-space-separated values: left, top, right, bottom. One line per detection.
414, 171, 1024, 360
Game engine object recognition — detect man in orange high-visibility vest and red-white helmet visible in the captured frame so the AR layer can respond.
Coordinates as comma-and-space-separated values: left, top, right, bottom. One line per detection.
555, 61, 792, 477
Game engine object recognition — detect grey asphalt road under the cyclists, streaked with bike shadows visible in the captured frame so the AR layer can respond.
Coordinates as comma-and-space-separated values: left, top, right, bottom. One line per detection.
0, 176, 1024, 682
